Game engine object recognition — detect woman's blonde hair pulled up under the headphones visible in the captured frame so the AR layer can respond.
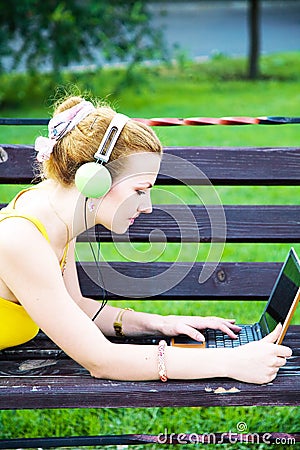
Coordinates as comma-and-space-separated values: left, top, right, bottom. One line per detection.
40, 96, 162, 186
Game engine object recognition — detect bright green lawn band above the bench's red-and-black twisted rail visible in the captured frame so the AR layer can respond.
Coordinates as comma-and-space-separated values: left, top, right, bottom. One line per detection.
0, 52, 300, 110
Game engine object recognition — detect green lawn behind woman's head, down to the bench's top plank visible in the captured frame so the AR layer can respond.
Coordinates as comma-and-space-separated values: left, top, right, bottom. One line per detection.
0, 53, 300, 146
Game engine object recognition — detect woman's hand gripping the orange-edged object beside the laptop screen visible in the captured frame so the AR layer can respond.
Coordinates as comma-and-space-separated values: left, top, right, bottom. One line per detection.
228, 324, 292, 384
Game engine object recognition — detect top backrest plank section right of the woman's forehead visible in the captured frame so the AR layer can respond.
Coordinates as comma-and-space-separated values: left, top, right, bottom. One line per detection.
163, 147, 300, 185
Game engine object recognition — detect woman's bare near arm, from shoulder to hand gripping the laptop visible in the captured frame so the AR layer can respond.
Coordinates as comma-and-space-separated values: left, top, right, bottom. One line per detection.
0, 218, 291, 383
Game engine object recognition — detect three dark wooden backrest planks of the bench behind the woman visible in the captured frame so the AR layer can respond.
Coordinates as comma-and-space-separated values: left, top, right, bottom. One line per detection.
0, 145, 300, 300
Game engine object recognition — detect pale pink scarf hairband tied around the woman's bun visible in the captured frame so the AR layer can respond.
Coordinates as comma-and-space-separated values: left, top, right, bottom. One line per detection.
34, 100, 96, 162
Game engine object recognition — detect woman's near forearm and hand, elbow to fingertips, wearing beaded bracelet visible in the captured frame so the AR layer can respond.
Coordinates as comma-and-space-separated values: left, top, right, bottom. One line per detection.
83, 327, 292, 384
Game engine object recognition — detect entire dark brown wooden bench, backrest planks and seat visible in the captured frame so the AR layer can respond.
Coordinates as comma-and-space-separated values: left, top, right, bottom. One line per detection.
0, 139, 300, 448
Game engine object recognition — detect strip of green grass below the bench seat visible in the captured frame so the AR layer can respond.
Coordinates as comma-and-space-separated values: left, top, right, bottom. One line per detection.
0, 407, 299, 449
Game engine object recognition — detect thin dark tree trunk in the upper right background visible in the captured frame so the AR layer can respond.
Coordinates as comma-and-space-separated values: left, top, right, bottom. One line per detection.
248, 0, 260, 80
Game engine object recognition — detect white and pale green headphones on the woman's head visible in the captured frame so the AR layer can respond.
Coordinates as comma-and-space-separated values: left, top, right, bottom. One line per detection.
75, 113, 129, 198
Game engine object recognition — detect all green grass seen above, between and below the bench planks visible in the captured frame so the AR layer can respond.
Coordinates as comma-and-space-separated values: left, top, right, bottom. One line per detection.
0, 54, 300, 449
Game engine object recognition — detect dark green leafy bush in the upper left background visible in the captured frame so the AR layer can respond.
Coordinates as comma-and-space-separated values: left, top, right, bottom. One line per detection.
0, 0, 162, 75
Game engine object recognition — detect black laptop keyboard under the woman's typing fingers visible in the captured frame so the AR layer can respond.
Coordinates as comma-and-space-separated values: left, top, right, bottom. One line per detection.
204, 325, 257, 348
